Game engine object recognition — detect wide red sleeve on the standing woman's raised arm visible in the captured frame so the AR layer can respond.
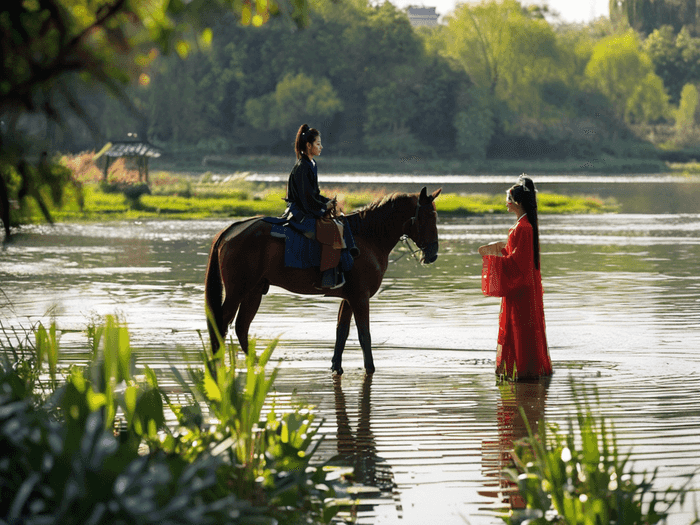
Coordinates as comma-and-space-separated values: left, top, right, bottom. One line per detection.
481, 220, 535, 297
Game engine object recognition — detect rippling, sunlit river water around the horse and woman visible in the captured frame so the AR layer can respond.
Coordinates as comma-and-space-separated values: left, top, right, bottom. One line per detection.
0, 180, 700, 525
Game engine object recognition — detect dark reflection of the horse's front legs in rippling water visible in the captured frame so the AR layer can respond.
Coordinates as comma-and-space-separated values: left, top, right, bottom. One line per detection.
328, 375, 403, 519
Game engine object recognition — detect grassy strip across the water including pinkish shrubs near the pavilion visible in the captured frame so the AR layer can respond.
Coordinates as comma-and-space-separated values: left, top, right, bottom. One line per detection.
4, 154, 618, 224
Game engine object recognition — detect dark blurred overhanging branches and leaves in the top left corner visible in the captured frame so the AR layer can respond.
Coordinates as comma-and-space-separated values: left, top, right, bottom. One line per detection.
0, 0, 308, 242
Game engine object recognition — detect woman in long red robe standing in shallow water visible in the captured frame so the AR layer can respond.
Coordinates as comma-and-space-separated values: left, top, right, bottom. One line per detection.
479, 175, 552, 380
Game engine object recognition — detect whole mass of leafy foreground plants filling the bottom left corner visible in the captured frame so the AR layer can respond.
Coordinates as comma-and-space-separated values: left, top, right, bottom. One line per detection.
0, 316, 340, 525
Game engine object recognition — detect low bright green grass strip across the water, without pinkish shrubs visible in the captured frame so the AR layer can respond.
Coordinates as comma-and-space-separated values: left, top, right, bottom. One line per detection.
16, 173, 618, 222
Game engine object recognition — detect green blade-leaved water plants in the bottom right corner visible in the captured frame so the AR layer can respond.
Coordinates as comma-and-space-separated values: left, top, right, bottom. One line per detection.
503, 383, 693, 525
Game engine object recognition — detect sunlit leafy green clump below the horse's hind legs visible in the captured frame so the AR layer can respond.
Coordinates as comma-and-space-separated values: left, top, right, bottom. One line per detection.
163, 314, 338, 523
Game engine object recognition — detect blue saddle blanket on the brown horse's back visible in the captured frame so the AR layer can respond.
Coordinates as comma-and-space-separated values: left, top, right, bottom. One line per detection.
262, 217, 355, 272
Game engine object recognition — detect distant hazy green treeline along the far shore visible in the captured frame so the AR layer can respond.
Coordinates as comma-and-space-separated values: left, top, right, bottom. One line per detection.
34, 0, 700, 159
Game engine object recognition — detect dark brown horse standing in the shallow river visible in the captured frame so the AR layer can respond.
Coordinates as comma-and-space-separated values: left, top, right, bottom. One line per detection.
205, 188, 441, 375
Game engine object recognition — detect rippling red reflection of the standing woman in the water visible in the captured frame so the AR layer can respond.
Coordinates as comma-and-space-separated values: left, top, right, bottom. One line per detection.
479, 377, 550, 510
